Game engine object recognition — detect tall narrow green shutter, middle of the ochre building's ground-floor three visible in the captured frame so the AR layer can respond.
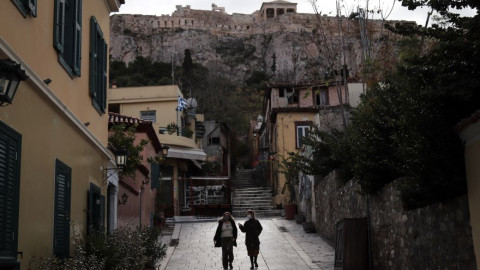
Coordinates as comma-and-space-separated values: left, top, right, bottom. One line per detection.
53, 159, 72, 258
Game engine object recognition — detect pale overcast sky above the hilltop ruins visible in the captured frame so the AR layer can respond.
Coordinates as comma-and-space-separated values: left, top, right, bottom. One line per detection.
115, 0, 438, 24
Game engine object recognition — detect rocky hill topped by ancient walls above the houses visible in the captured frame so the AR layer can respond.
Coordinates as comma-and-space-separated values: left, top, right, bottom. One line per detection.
110, 6, 412, 85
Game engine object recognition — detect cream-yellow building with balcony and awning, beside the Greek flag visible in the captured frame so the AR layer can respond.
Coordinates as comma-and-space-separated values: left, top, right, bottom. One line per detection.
108, 85, 206, 216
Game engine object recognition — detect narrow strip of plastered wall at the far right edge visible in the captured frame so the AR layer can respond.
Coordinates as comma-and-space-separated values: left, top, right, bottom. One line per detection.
457, 111, 480, 264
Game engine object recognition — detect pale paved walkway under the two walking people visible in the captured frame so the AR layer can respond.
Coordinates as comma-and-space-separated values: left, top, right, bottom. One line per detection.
160, 218, 335, 270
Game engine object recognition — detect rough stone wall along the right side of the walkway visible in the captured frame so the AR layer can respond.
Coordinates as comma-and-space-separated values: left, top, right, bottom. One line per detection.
314, 172, 476, 269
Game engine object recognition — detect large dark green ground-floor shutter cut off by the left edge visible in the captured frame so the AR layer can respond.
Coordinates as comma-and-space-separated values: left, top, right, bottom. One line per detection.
0, 121, 22, 267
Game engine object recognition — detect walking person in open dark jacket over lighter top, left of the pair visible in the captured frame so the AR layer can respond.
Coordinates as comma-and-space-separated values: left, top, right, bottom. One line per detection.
213, 212, 237, 269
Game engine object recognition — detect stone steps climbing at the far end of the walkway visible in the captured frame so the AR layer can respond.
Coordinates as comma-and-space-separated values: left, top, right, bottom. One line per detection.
232, 169, 281, 217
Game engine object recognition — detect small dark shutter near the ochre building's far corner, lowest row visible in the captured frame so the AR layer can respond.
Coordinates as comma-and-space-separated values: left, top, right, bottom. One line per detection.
87, 183, 105, 232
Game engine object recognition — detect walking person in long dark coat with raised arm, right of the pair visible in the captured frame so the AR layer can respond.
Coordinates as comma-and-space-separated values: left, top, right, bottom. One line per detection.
238, 210, 263, 269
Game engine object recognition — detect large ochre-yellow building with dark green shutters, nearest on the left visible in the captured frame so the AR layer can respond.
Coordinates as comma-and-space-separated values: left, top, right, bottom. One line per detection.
0, 0, 124, 269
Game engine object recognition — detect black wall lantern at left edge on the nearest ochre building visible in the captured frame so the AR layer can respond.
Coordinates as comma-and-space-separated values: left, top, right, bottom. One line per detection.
0, 59, 28, 106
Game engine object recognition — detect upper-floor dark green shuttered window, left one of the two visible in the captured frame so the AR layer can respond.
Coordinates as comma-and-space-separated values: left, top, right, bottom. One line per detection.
53, 0, 82, 77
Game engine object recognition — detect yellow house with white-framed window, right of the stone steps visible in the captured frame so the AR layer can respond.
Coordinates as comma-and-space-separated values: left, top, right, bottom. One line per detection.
253, 84, 352, 205
